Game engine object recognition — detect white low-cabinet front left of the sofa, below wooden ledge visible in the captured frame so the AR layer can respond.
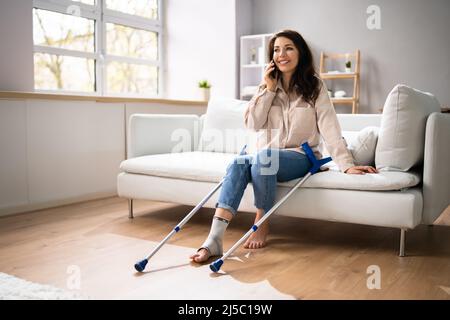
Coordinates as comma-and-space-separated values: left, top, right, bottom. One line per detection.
0, 99, 125, 216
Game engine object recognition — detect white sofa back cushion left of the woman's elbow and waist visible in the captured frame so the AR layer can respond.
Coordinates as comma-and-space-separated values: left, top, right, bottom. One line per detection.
198, 98, 252, 153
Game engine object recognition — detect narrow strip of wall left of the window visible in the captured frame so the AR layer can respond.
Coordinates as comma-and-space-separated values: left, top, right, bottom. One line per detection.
0, 0, 34, 91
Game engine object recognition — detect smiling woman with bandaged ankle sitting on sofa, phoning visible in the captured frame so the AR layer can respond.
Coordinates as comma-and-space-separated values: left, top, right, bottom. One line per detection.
190, 30, 377, 262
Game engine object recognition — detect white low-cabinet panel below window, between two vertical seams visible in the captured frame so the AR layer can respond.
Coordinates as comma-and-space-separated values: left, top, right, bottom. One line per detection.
27, 100, 125, 204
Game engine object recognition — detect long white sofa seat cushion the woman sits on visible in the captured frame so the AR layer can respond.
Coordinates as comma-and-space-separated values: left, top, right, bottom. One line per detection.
120, 151, 420, 190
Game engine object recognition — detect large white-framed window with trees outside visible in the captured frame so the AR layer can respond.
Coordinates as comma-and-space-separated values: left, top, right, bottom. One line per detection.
33, 0, 162, 96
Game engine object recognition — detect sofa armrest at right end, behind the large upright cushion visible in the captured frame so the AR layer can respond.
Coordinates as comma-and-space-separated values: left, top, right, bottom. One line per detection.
422, 112, 450, 224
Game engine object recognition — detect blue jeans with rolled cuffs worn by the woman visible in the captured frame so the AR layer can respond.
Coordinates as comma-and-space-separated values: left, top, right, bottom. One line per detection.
216, 149, 312, 215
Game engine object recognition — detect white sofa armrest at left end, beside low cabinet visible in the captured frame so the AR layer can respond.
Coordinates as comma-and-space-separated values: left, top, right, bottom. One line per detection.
127, 114, 199, 158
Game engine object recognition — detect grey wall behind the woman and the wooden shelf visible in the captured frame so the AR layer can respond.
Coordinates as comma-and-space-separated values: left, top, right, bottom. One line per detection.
252, 0, 450, 113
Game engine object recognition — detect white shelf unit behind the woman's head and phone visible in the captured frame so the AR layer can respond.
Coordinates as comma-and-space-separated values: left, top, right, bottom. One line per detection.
239, 34, 273, 100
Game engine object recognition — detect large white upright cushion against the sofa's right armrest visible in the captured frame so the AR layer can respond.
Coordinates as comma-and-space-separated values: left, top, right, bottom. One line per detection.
375, 84, 440, 171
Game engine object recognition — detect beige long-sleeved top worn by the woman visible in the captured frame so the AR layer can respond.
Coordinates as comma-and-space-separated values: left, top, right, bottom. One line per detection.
244, 81, 354, 172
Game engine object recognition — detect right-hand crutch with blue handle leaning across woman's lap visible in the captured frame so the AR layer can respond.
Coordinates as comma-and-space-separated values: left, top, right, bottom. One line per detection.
209, 142, 331, 272
